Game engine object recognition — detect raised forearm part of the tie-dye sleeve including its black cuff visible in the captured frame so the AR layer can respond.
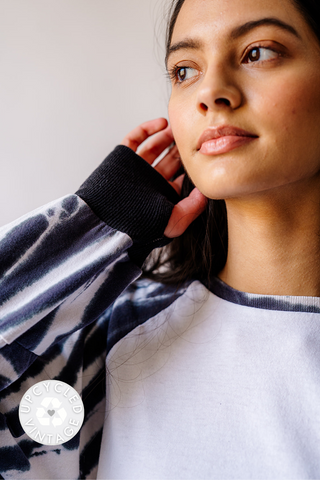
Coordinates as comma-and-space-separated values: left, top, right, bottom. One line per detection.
0, 146, 179, 387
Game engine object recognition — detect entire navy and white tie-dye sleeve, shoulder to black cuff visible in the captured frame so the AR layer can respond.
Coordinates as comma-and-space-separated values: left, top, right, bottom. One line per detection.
0, 146, 179, 479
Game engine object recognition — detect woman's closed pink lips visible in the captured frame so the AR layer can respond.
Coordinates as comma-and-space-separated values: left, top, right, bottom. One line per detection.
197, 125, 258, 155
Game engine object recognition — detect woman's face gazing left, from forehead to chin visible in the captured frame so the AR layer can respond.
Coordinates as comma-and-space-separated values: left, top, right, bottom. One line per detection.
168, 0, 320, 199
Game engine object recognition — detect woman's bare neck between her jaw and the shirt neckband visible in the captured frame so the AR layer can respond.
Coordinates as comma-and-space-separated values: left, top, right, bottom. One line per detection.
219, 182, 320, 297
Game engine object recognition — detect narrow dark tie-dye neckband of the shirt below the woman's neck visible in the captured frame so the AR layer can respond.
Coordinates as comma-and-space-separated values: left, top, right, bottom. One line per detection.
208, 277, 320, 313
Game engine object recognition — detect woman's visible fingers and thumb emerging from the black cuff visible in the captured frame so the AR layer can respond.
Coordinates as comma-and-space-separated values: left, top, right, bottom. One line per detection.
121, 118, 207, 238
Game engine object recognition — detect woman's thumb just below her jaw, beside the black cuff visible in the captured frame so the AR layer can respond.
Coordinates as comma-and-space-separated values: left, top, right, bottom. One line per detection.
164, 188, 208, 238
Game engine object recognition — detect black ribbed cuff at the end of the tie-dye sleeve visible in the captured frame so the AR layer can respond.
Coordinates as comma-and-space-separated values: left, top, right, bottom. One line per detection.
76, 145, 180, 258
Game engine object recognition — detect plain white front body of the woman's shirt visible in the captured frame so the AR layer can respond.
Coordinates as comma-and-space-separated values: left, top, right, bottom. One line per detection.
98, 281, 320, 480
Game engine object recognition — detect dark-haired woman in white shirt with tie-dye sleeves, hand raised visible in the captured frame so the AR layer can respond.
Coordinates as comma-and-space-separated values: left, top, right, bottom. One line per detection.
0, 0, 320, 479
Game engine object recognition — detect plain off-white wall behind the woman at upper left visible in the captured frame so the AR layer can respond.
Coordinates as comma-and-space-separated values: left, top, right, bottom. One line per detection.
0, 0, 170, 225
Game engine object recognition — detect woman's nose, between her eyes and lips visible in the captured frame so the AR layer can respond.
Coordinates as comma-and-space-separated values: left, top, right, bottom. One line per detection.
197, 66, 243, 114
